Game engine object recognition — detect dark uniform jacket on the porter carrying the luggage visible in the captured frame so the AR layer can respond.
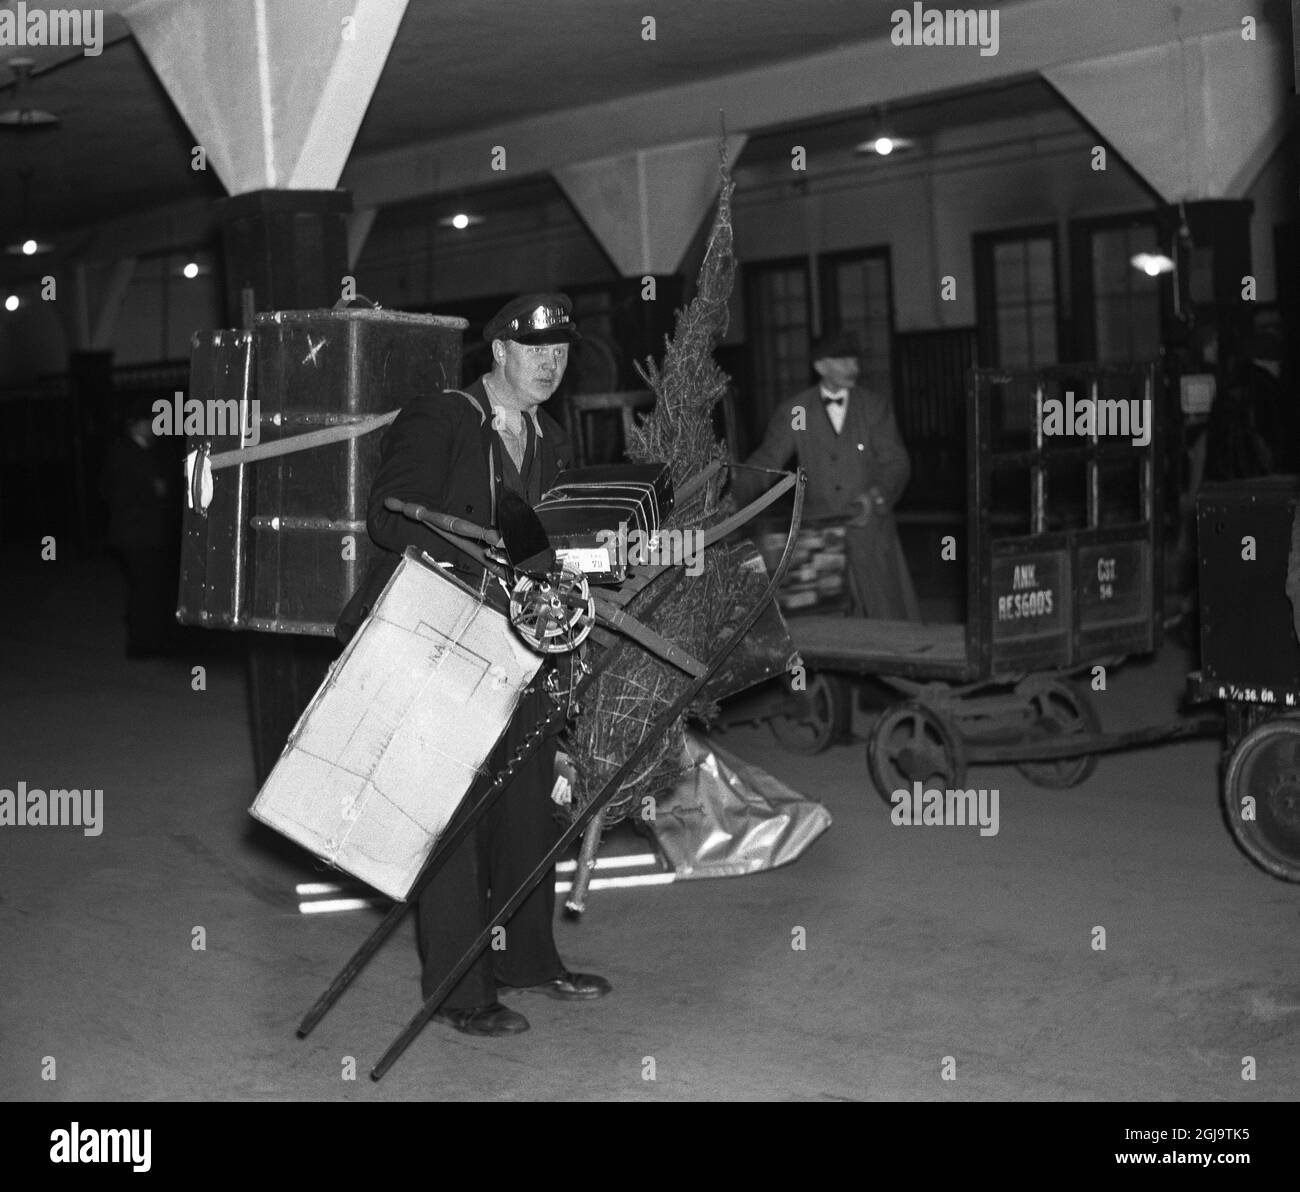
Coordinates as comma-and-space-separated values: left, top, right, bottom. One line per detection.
335, 380, 571, 641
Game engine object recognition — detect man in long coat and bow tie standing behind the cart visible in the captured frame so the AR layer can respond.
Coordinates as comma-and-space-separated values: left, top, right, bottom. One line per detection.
737, 333, 920, 620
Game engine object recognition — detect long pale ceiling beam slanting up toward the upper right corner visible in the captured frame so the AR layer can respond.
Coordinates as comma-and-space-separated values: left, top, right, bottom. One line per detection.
342, 0, 1263, 207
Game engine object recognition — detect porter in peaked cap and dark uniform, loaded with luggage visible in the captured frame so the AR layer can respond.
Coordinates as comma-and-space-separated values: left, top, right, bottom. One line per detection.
342, 294, 610, 1035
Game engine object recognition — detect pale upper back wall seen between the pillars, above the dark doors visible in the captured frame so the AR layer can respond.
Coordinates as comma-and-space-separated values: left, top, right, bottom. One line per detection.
0, 96, 1291, 386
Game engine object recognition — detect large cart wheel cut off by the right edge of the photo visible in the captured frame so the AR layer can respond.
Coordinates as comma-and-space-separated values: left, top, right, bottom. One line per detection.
1223, 716, 1300, 881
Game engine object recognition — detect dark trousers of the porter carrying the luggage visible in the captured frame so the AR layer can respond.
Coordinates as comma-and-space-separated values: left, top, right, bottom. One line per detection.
416, 692, 562, 1010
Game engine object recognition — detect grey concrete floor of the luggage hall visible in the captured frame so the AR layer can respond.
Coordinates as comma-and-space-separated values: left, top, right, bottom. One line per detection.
0, 554, 1300, 1101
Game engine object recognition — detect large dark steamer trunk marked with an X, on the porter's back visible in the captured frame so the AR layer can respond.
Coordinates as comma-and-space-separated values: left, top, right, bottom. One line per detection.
177, 309, 465, 783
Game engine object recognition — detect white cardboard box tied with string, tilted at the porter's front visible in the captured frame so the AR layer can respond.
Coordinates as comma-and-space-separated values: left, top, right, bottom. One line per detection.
250, 549, 542, 900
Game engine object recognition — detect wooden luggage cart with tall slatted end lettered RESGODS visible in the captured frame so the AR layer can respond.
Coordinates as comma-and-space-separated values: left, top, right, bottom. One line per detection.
759, 364, 1221, 799
